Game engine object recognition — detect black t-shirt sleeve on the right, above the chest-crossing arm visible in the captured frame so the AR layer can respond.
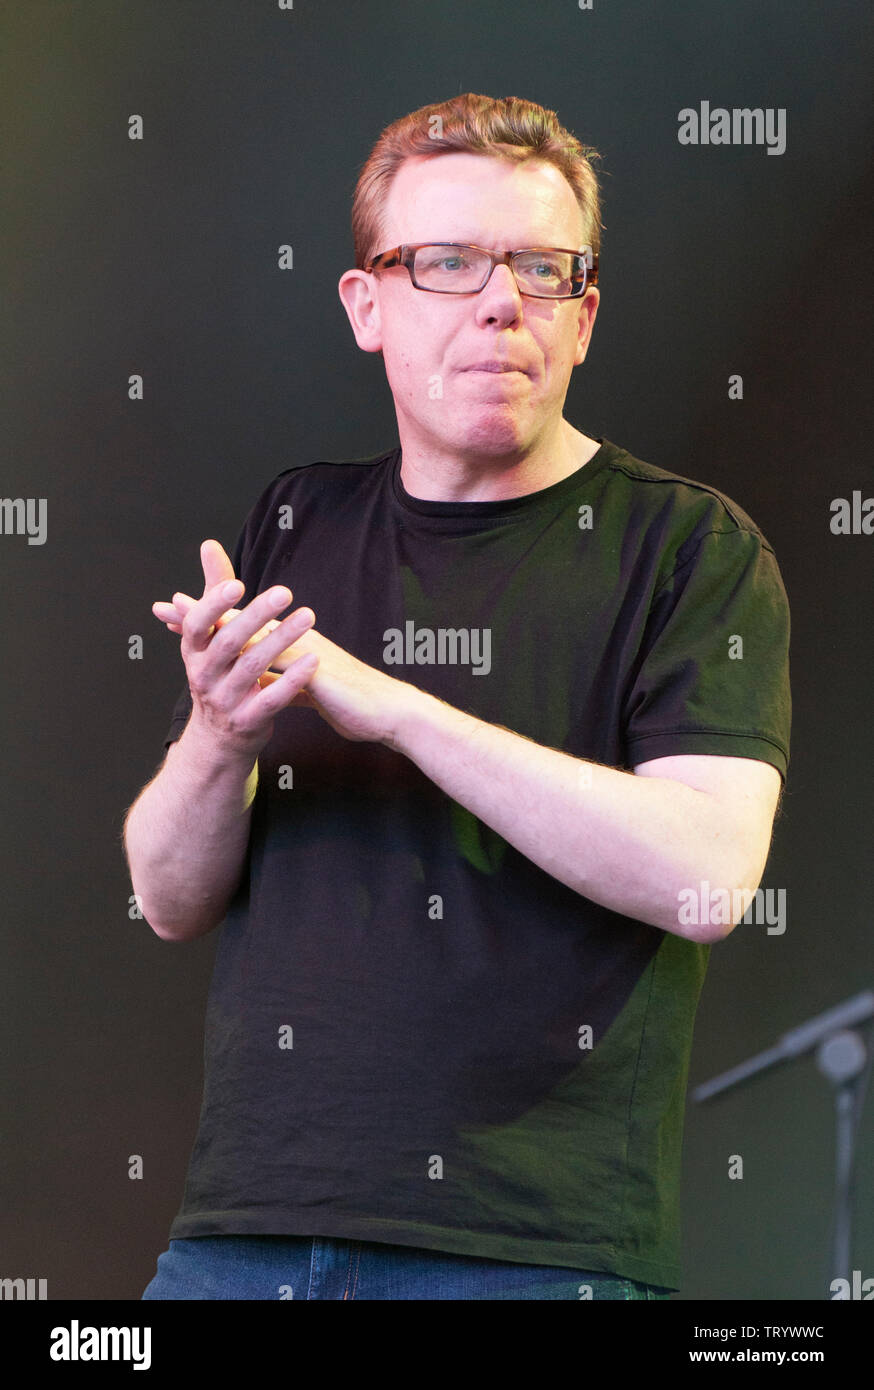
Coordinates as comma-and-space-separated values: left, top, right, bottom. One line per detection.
624, 528, 792, 780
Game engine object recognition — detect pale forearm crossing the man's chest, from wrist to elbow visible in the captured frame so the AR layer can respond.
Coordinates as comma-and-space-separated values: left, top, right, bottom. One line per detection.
390, 687, 734, 935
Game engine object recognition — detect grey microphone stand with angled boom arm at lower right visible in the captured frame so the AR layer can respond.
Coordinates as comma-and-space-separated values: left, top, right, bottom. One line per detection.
692, 990, 874, 1298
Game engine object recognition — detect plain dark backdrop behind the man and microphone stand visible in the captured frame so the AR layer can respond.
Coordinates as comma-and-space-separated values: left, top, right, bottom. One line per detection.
0, 0, 874, 1300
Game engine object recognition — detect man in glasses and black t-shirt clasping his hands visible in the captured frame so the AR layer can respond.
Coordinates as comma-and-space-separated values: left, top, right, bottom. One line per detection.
125, 93, 789, 1300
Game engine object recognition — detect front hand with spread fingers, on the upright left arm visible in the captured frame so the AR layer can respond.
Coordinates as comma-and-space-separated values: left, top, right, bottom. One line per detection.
151, 541, 318, 758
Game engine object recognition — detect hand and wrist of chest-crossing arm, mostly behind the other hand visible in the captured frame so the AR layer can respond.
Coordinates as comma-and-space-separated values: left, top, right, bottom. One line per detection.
151, 541, 415, 745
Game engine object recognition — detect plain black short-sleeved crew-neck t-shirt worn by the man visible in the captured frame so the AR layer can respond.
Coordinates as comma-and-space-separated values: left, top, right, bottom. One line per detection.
160, 439, 791, 1289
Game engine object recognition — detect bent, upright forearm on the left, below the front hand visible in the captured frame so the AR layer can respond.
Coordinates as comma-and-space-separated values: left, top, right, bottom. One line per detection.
124, 723, 257, 941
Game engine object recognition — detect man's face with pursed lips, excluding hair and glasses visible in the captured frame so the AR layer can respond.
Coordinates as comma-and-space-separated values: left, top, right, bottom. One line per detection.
340, 153, 599, 457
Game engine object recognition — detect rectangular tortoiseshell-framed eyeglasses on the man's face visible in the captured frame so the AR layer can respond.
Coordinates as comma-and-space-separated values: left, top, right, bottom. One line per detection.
364, 242, 597, 299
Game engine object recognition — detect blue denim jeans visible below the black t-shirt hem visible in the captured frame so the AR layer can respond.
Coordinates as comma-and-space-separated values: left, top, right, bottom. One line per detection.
142, 1236, 671, 1300
